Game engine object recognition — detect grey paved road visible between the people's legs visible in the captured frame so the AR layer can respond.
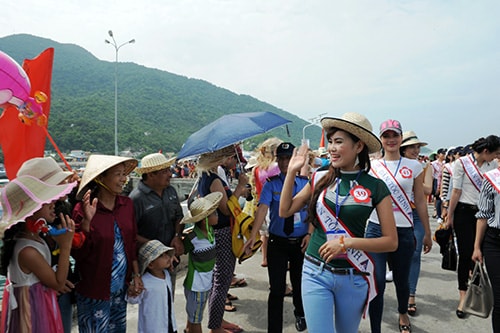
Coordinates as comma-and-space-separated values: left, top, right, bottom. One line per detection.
74, 210, 491, 333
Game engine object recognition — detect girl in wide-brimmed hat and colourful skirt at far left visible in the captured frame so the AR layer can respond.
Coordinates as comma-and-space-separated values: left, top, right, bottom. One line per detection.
0, 176, 76, 333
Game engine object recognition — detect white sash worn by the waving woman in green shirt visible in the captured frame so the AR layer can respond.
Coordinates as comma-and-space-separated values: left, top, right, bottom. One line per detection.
316, 189, 378, 316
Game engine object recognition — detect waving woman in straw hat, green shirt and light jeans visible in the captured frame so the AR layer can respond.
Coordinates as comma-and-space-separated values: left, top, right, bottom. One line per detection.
279, 113, 398, 333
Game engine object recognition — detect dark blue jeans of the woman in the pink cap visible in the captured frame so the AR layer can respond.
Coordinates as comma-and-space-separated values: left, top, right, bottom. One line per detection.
365, 222, 415, 333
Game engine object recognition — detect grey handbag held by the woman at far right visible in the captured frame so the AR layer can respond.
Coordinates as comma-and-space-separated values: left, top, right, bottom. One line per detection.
463, 261, 493, 318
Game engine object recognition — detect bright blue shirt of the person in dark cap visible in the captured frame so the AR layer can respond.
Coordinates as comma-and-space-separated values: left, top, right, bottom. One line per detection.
259, 173, 309, 238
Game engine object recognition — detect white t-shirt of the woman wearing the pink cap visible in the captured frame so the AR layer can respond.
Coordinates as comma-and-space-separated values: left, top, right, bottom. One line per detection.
369, 157, 423, 228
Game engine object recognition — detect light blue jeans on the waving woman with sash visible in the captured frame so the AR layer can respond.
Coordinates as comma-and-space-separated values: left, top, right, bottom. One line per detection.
300, 260, 368, 333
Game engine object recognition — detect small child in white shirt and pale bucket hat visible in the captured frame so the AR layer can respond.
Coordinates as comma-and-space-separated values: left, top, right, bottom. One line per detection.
127, 240, 177, 333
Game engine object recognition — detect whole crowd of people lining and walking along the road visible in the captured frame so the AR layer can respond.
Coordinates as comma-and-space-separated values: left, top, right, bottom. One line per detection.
0, 113, 500, 333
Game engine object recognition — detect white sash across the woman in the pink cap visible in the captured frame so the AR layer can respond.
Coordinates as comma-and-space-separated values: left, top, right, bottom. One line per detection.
372, 160, 413, 226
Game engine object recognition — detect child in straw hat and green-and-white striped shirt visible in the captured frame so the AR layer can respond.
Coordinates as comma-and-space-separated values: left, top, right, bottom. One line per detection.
181, 192, 222, 333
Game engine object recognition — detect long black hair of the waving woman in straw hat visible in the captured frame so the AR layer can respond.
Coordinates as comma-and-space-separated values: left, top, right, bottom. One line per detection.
307, 127, 371, 228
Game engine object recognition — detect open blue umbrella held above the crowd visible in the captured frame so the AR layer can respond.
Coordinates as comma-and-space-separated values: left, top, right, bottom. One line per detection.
177, 112, 291, 159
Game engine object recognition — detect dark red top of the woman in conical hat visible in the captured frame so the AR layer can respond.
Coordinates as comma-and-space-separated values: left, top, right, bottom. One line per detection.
71, 195, 137, 300
